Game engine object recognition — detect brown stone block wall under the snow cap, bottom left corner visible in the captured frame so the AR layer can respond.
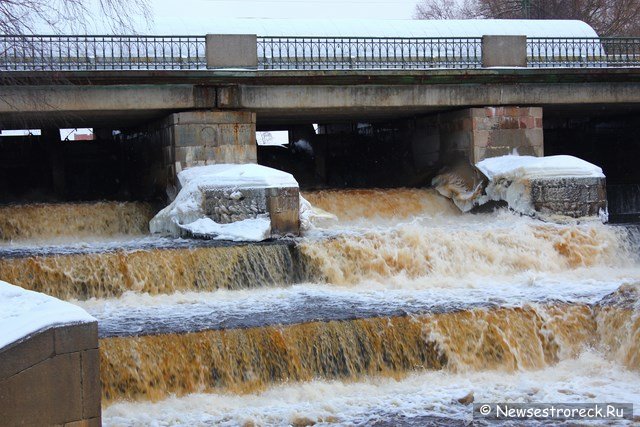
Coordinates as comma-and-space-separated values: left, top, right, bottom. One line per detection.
0, 322, 101, 427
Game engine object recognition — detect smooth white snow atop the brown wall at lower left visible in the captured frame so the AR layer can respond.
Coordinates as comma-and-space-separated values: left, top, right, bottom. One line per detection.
0, 280, 96, 349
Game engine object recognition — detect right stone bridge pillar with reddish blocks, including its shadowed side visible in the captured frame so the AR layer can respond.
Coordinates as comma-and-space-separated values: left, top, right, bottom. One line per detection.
438, 107, 544, 164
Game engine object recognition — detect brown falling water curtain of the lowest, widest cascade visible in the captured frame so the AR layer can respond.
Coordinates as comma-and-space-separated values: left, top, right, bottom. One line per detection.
95, 286, 640, 401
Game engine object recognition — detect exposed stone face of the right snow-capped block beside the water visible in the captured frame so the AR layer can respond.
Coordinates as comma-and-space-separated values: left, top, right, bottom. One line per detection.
529, 177, 607, 218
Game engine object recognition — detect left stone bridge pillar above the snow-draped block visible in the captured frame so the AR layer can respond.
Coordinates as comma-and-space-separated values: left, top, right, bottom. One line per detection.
161, 111, 257, 173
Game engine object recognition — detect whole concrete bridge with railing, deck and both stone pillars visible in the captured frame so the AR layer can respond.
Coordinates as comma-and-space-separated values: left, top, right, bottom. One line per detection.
0, 34, 640, 206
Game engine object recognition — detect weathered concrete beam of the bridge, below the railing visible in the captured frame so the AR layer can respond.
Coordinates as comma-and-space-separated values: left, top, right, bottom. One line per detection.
0, 79, 640, 129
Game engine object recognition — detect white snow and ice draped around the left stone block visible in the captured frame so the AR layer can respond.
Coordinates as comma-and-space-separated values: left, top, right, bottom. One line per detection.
149, 164, 298, 241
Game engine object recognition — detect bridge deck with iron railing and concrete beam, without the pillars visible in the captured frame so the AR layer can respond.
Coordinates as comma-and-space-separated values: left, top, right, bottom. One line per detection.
0, 35, 640, 129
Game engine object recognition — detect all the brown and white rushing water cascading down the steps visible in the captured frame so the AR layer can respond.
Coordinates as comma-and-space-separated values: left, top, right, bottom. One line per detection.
0, 189, 640, 426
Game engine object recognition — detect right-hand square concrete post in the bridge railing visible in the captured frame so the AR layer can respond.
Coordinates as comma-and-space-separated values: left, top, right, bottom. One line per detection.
482, 36, 527, 67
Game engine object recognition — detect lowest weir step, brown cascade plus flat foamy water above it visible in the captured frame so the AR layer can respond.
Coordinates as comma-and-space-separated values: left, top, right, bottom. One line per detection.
95, 288, 638, 401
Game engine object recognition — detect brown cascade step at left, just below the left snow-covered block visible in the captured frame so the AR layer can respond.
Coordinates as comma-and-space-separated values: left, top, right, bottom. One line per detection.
0, 238, 307, 300
